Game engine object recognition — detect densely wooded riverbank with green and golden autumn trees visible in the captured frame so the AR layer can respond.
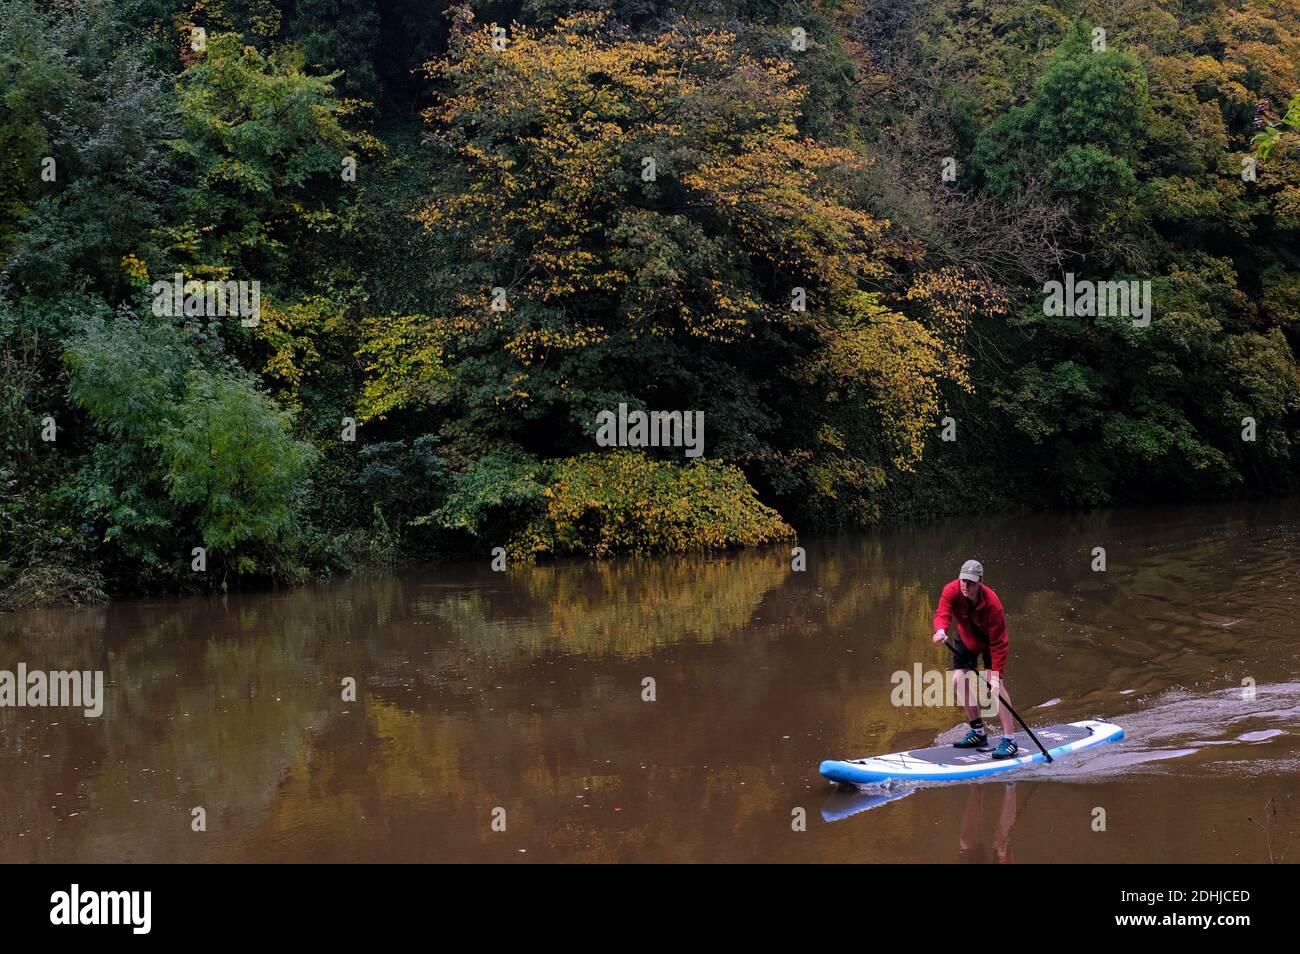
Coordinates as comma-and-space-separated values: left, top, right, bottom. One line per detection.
0, 0, 1300, 621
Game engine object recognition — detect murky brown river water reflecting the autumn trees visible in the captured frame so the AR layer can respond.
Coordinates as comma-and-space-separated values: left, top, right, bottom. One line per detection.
0, 500, 1300, 863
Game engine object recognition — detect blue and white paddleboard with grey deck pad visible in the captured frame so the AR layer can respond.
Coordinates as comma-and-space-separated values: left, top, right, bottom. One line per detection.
819, 719, 1125, 785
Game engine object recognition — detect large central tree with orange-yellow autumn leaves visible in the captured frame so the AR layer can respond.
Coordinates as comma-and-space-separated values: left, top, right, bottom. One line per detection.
364, 14, 959, 530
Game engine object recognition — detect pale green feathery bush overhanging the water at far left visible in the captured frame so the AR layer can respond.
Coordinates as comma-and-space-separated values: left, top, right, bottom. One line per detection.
66, 316, 313, 580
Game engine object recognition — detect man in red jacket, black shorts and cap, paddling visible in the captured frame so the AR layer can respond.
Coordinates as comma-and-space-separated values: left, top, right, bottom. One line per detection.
935, 560, 1019, 759
